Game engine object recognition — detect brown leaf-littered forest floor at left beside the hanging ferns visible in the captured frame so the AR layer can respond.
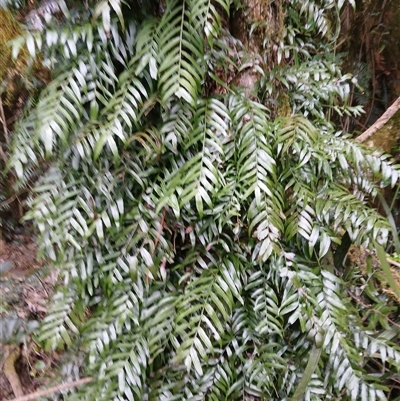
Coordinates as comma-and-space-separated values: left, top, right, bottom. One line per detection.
0, 232, 59, 401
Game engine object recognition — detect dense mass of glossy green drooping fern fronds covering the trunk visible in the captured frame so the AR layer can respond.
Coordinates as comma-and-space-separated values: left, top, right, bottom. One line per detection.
3, 0, 400, 401
